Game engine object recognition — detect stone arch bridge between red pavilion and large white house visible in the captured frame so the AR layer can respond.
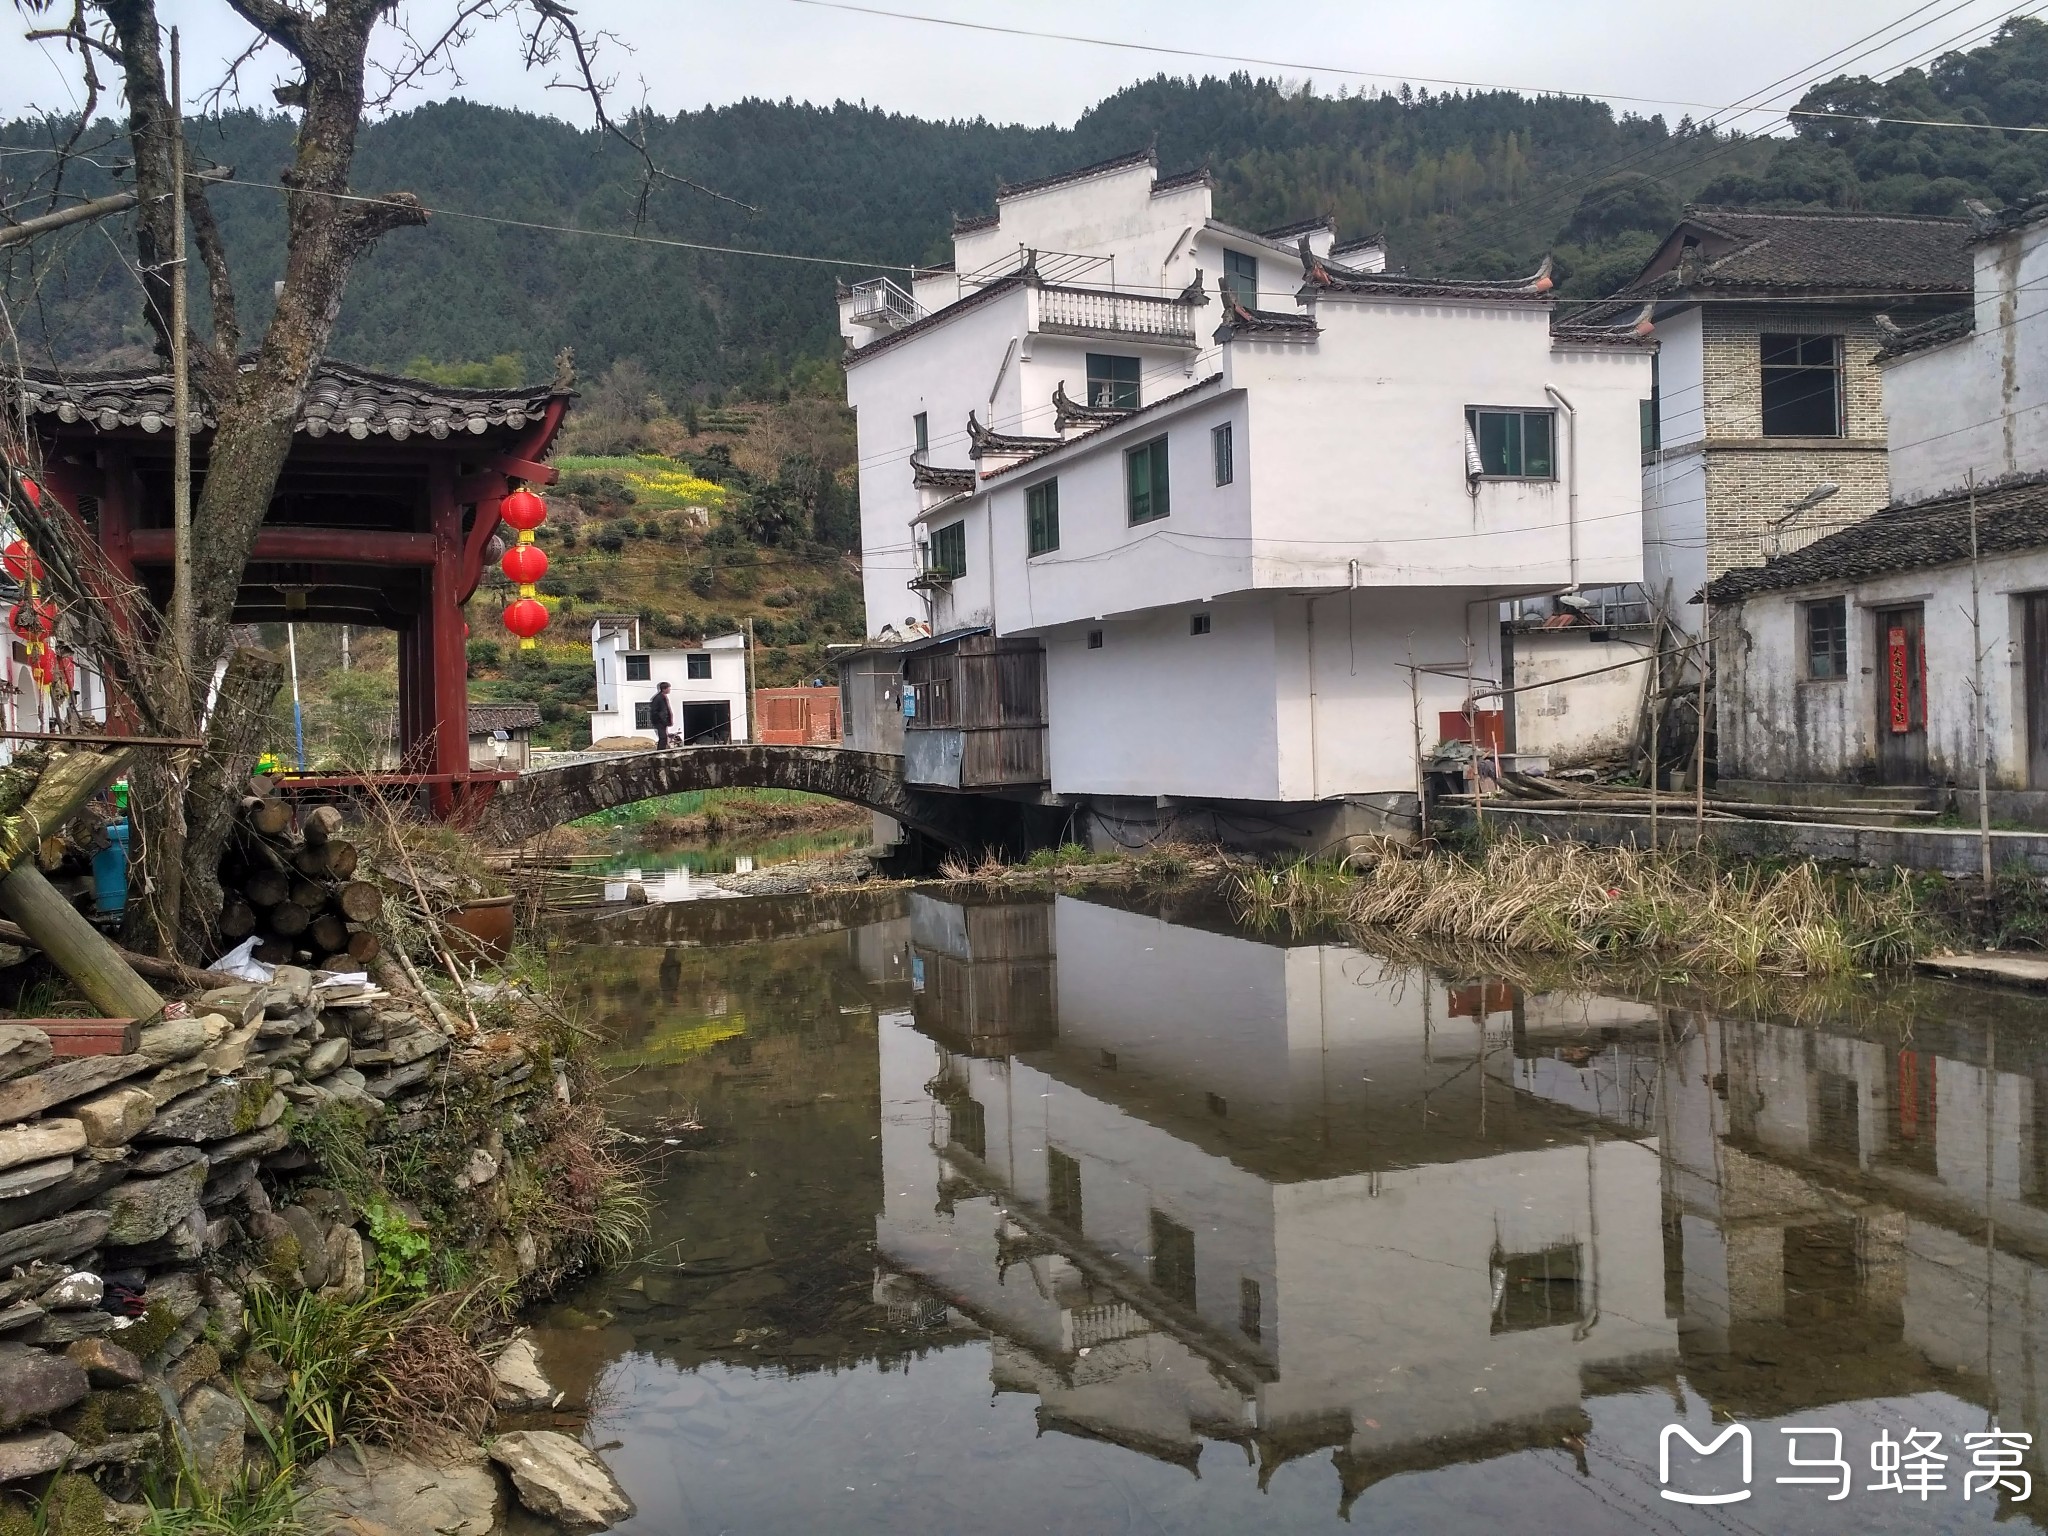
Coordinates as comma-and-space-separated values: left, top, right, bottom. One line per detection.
475, 743, 1067, 850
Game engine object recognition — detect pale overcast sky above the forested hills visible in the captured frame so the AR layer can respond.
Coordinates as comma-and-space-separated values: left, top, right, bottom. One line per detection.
0, 0, 2013, 125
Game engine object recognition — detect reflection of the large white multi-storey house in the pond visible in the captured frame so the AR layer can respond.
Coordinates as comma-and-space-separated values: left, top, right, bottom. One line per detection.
879, 897, 1677, 1503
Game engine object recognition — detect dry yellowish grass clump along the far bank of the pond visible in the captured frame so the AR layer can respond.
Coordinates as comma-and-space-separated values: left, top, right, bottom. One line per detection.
1239, 836, 1935, 975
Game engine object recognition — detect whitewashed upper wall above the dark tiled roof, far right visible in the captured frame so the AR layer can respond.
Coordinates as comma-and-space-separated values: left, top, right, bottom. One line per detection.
1884, 219, 2048, 502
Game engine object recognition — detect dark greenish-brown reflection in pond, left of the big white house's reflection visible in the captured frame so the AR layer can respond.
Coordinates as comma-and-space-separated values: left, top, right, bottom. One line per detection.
548, 932, 961, 1372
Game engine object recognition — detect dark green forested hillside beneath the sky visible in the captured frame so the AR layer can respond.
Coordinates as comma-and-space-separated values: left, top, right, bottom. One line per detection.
0, 20, 2048, 403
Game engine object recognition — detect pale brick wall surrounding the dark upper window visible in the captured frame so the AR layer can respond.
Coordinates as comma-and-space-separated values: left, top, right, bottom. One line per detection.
1704, 303, 1890, 578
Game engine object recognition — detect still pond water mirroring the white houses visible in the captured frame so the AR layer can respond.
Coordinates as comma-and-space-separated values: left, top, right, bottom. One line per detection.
539, 891, 2048, 1536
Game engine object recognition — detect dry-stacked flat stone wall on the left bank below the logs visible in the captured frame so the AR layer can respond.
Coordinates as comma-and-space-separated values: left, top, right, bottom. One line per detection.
0, 967, 537, 1515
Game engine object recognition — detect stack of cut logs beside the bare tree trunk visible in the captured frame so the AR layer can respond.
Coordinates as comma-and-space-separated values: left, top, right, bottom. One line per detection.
221, 795, 383, 971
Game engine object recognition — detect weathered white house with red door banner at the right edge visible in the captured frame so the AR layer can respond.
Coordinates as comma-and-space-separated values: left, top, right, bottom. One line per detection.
1708, 201, 2048, 823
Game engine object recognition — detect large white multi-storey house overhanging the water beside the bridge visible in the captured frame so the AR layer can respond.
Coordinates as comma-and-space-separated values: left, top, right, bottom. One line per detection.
840, 154, 1651, 842
